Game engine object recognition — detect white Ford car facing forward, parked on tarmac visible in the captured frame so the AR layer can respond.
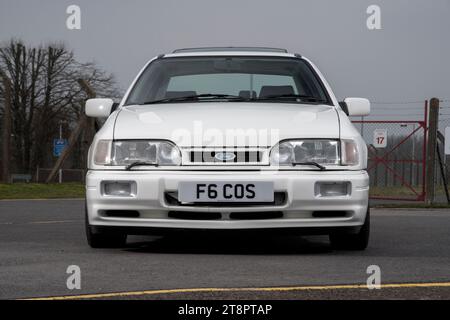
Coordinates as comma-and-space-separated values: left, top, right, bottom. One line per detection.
86, 47, 370, 250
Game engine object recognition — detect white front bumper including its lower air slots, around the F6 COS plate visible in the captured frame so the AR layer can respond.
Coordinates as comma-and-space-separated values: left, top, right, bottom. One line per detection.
86, 170, 369, 230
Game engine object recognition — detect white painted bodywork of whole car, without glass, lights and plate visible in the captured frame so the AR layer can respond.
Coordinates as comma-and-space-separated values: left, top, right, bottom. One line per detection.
86, 51, 370, 229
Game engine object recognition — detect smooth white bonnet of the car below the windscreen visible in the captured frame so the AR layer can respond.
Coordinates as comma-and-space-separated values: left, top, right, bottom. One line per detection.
114, 102, 339, 147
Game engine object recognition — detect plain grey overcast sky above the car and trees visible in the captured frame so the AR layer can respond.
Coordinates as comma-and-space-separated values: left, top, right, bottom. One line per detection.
0, 0, 450, 123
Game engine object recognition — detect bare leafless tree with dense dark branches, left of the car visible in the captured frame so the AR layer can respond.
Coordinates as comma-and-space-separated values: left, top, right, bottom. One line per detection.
0, 40, 119, 176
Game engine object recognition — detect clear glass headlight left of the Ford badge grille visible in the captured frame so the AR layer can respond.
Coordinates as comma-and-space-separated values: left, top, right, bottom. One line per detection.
94, 140, 181, 166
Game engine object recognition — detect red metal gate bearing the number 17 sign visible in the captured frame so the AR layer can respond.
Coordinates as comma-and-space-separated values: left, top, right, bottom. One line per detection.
352, 102, 428, 201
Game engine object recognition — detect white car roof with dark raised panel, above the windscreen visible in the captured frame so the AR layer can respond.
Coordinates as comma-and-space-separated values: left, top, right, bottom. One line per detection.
163, 47, 300, 57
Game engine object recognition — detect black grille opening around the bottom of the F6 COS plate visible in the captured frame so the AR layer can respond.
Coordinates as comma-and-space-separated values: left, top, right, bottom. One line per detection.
164, 191, 287, 207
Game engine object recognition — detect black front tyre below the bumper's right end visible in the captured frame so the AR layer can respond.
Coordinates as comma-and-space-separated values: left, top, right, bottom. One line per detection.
330, 208, 370, 250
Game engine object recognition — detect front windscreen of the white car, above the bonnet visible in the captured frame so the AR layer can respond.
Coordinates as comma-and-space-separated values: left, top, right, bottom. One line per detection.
126, 56, 329, 105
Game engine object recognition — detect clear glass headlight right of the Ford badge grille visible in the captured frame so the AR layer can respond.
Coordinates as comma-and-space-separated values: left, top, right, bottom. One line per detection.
270, 140, 340, 166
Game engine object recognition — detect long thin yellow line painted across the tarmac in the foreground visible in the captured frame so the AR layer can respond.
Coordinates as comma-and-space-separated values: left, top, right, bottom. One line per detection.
19, 282, 450, 300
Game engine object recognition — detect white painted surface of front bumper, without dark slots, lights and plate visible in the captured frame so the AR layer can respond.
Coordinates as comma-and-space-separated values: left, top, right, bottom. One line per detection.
86, 170, 369, 229
